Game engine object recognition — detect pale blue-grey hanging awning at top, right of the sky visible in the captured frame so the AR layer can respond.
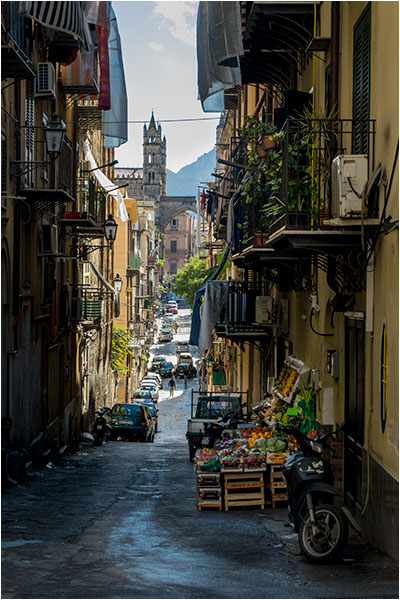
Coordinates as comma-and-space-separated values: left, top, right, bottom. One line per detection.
197, 2, 244, 112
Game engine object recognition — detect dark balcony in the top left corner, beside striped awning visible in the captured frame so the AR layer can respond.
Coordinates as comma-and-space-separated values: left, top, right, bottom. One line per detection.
1, 2, 35, 79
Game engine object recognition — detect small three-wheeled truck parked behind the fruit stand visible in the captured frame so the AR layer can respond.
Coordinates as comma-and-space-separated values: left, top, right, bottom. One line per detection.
186, 390, 247, 460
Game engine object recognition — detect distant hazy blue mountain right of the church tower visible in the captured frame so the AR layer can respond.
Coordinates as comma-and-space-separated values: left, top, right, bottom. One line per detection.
167, 147, 215, 196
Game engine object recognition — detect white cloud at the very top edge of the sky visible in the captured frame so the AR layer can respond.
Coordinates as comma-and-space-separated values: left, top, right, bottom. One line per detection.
154, 2, 197, 47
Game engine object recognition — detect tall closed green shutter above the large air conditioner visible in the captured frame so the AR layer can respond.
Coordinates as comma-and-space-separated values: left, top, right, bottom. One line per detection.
353, 5, 371, 154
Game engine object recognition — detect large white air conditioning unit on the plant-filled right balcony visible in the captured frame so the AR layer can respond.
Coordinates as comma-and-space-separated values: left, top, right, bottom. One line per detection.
332, 154, 368, 219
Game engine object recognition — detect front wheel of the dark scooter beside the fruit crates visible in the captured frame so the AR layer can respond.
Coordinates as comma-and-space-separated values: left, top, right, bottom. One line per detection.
299, 504, 349, 563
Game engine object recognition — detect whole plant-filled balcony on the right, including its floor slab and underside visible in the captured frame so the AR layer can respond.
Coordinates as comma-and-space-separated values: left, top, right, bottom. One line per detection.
230, 119, 379, 289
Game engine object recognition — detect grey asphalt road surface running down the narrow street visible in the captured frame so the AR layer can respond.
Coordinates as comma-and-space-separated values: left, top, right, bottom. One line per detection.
2, 311, 398, 598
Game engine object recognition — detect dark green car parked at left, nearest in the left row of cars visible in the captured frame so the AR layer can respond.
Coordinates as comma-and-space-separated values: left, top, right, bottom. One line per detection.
111, 403, 155, 442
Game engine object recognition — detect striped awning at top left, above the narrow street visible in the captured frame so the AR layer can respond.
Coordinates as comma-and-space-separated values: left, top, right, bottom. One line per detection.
19, 2, 89, 49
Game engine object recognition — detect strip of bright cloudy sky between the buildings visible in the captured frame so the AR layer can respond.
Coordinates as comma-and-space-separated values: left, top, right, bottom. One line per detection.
112, 0, 219, 173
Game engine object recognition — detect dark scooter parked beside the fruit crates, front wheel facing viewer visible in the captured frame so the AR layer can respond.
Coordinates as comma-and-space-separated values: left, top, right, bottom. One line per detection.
282, 422, 349, 563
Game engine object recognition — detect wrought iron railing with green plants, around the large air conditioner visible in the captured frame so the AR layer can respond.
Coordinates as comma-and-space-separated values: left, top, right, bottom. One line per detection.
234, 119, 377, 251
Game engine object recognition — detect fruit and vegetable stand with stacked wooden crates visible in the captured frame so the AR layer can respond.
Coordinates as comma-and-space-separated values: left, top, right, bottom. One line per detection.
194, 357, 316, 510
